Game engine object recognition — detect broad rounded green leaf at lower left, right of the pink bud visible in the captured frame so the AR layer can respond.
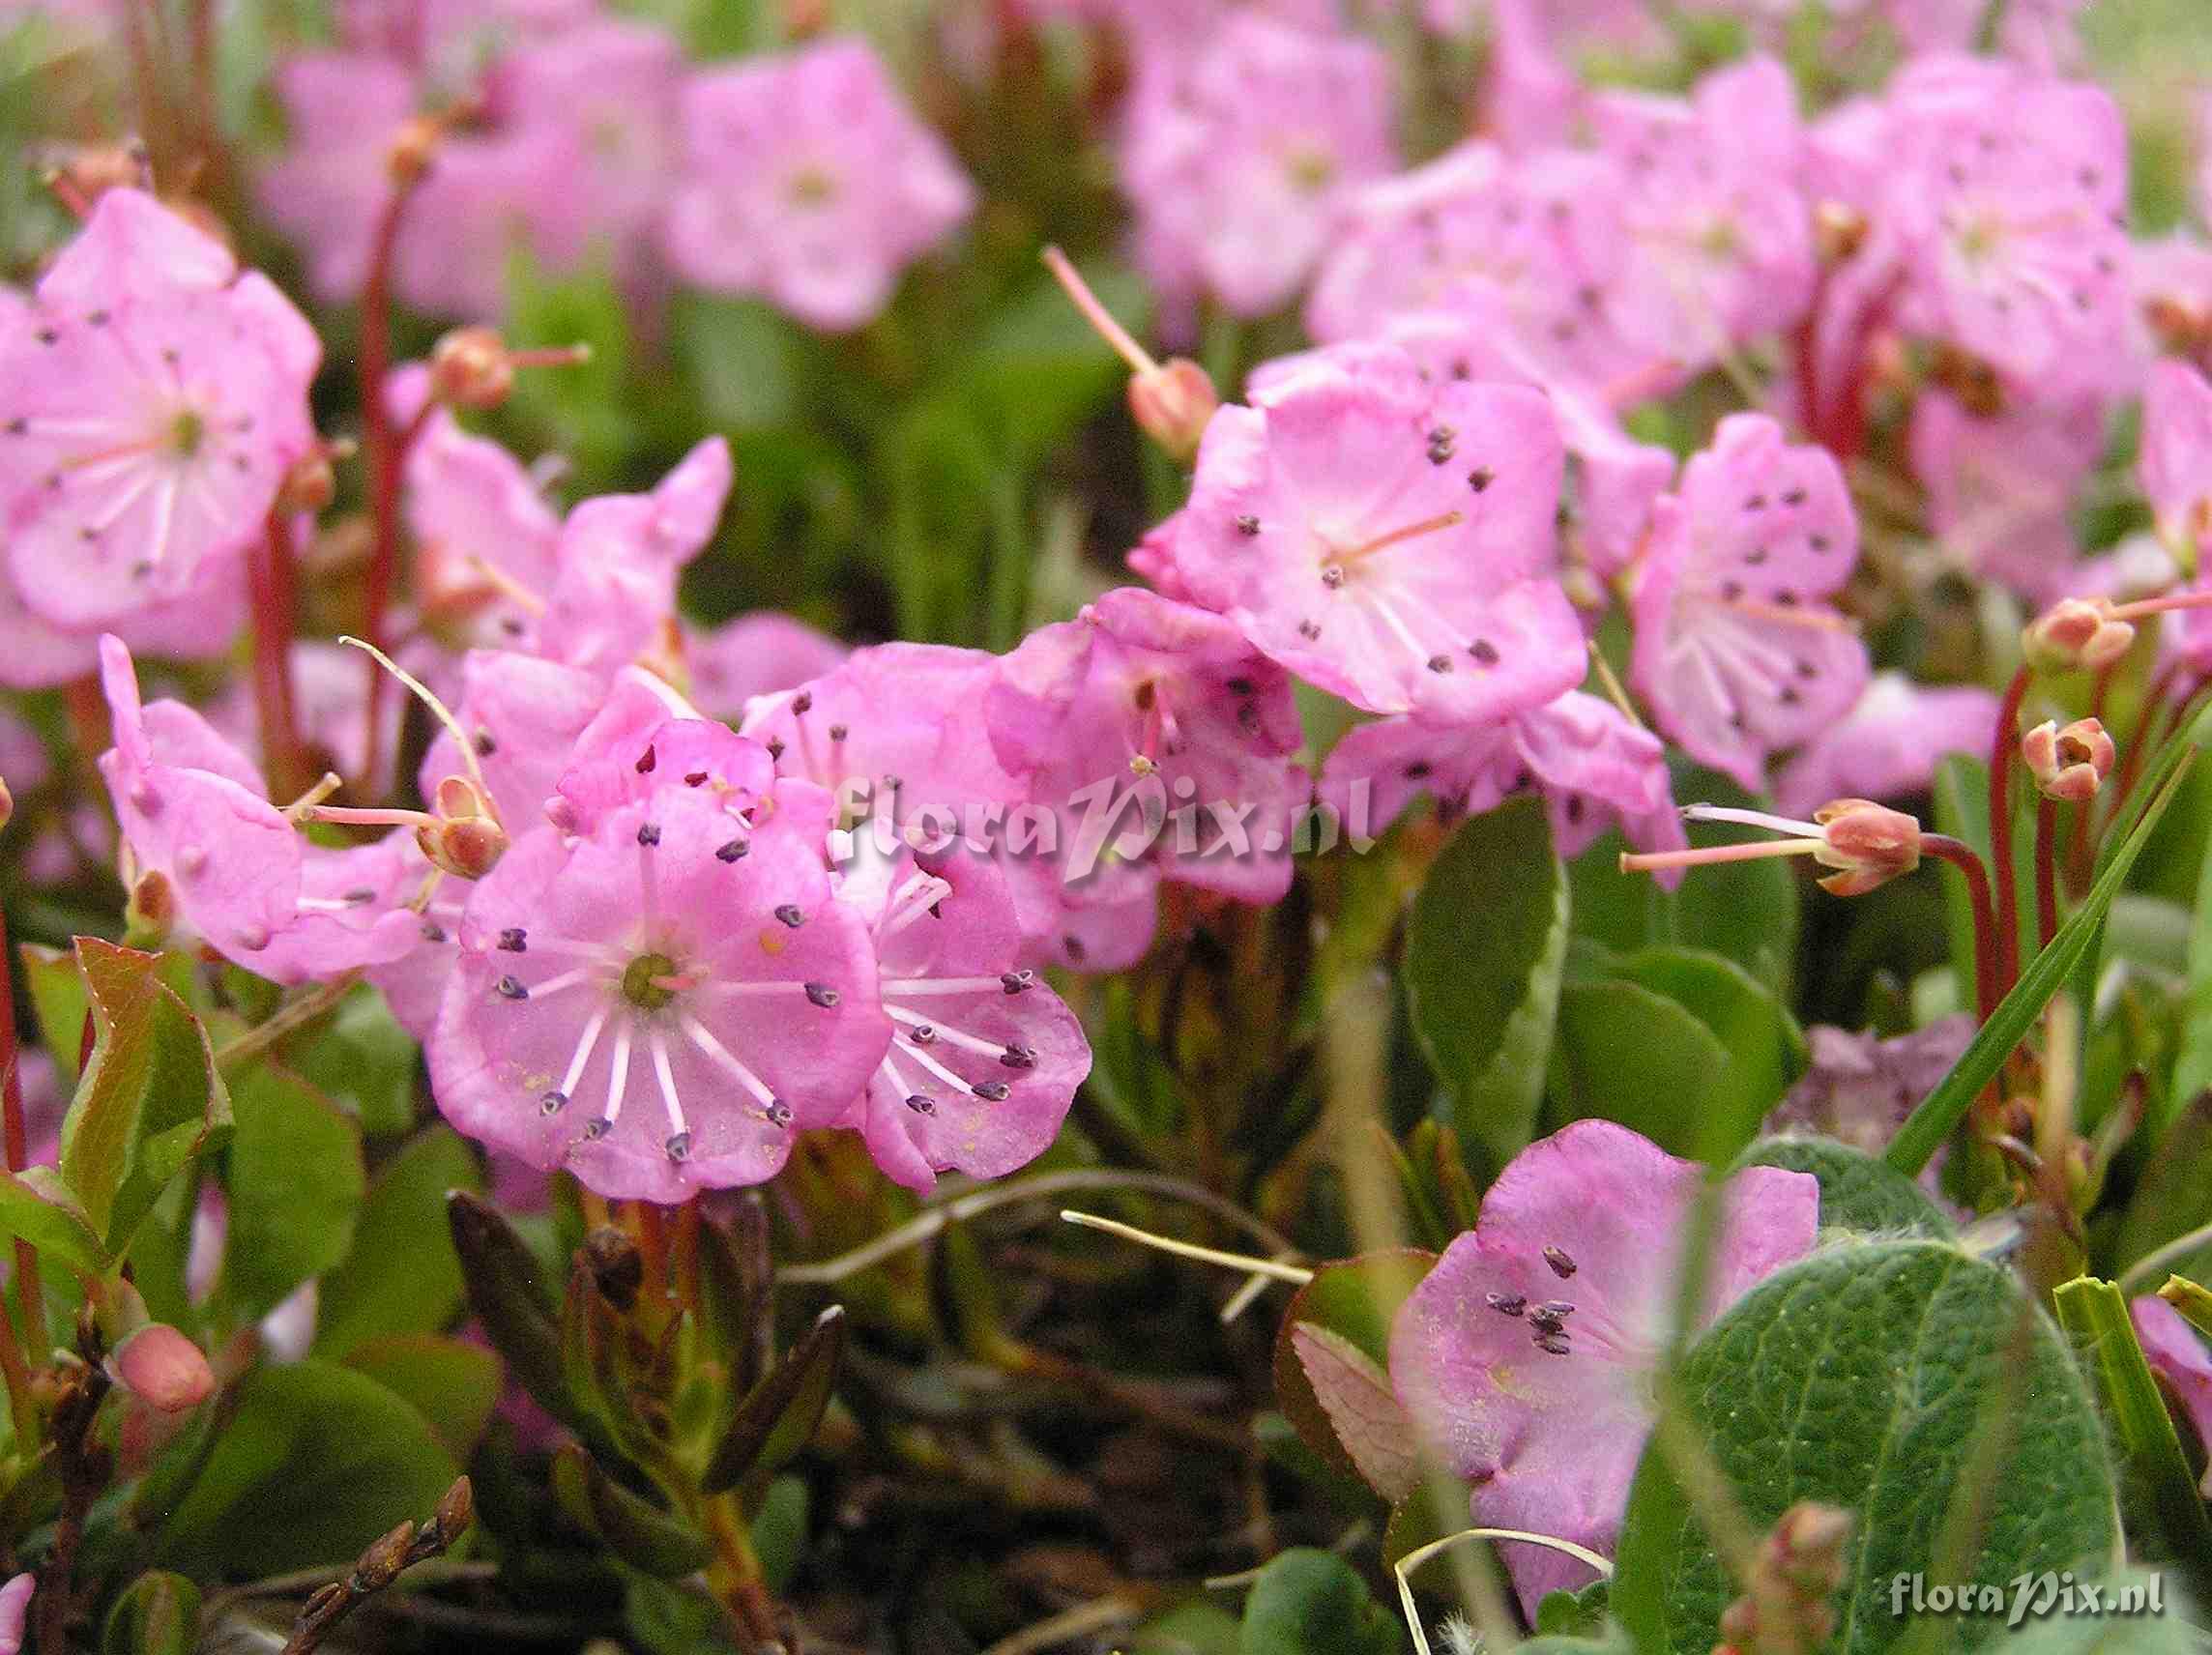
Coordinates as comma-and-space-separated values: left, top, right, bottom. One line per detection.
153, 1358, 460, 1580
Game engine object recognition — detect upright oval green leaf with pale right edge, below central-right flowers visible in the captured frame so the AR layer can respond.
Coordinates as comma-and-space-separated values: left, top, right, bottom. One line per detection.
1405, 798, 1568, 1166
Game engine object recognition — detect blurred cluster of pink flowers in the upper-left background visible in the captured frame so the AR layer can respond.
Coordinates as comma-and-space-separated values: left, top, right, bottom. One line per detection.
261, 0, 974, 330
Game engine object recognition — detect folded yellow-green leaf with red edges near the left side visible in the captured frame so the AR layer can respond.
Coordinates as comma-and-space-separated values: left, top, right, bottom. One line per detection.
62, 936, 230, 1255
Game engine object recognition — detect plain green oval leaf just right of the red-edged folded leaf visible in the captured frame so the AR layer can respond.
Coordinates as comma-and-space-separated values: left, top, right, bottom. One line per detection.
221, 1064, 369, 1319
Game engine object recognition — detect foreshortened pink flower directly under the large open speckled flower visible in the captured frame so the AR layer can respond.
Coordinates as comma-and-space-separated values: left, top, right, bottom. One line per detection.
1321, 690, 1688, 883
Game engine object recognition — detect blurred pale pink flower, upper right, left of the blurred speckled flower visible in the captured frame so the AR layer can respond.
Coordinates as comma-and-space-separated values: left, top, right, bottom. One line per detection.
1592, 58, 1814, 367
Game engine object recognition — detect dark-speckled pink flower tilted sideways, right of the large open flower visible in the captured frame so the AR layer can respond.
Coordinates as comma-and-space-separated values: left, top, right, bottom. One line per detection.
1630, 414, 1867, 790
